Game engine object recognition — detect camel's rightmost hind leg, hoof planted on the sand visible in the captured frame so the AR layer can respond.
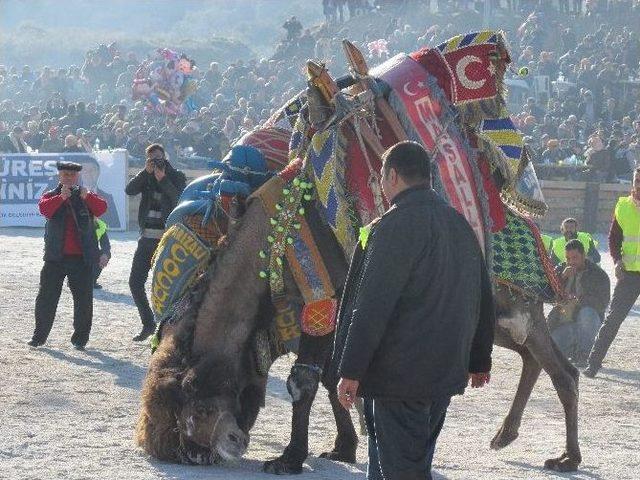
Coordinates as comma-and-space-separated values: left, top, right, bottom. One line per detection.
525, 328, 582, 472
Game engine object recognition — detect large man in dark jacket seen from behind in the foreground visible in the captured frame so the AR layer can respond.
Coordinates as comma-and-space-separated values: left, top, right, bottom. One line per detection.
329, 142, 495, 480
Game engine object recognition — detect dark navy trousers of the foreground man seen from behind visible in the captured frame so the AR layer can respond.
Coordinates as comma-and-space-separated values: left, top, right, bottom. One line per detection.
364, 397, 451, 480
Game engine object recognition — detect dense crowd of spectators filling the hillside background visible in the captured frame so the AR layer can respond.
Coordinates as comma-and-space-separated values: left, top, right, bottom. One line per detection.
0, 0, 640, 181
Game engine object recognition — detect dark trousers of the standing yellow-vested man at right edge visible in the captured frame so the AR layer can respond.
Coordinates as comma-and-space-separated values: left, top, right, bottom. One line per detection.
589, 272, 640, 368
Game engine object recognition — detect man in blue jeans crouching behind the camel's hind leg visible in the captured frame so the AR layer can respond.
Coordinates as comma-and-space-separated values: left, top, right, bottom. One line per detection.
547, 238, 611, 367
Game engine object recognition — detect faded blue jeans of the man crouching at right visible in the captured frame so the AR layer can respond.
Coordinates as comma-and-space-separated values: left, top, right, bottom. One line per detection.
551, 307, 602, 360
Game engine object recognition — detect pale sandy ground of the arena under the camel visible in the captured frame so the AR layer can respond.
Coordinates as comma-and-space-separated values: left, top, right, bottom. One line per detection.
0, 229, 640, 480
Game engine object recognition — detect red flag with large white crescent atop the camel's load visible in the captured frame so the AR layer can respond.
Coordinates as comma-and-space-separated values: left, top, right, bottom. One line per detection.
444, 44, 498, 104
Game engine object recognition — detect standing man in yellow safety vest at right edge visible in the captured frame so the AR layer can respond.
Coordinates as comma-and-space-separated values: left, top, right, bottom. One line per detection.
584, 168, 640, 378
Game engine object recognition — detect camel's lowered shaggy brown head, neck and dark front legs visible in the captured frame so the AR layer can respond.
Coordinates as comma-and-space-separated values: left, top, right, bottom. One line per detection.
136, 201, 358, 474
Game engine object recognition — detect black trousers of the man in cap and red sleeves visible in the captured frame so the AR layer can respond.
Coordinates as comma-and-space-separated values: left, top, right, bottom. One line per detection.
33, 256, 93, 346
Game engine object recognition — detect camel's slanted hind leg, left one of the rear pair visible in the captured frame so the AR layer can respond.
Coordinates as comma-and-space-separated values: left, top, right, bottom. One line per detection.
491, 344, 542, 450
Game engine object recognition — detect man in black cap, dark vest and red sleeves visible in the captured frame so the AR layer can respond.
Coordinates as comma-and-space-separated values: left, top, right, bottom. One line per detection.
29, 162, 107, 350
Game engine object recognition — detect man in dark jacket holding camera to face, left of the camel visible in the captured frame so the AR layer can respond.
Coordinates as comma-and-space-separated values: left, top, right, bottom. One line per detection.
125, 143, 187, 342
